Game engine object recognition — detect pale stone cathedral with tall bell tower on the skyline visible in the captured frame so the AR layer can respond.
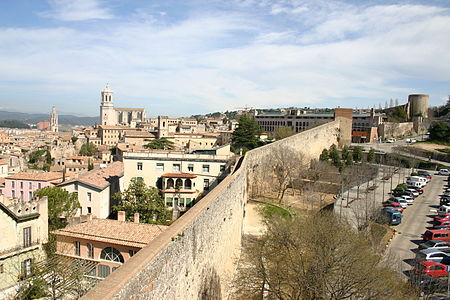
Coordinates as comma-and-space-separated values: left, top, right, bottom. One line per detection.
100, 85, 146, 127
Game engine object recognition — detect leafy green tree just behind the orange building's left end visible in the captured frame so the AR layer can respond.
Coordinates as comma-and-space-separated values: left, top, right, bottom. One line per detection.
35, 186, 80, 231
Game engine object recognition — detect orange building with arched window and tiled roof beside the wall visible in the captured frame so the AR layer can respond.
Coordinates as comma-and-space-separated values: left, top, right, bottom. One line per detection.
52, 211, 168, 279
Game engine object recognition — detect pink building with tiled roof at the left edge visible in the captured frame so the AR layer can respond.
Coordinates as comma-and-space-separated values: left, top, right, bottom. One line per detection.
1, 172, 63, 202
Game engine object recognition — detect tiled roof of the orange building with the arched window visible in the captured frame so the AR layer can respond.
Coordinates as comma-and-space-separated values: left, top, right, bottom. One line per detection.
53, 219, 168, 248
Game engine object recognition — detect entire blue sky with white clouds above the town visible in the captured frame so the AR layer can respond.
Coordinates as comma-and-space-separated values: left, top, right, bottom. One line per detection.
0, 0, 450, 116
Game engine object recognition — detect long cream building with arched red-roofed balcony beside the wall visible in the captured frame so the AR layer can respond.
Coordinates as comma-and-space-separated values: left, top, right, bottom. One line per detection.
122, 145, 232, 210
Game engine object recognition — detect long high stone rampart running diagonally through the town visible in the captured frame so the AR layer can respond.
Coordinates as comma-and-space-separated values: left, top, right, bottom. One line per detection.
83, 120, 341, 300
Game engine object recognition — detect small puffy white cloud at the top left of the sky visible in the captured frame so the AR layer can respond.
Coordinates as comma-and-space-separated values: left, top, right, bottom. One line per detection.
40, 0, 113, 21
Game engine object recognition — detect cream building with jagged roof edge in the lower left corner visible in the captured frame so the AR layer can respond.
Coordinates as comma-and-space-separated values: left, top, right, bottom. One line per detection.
0, 195, 48, 297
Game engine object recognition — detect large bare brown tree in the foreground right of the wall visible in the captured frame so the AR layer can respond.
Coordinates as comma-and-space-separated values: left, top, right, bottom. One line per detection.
233, 213, 414, 300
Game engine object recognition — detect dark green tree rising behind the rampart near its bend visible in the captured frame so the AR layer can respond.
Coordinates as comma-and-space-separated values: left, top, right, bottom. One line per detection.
231, 115, 261, 152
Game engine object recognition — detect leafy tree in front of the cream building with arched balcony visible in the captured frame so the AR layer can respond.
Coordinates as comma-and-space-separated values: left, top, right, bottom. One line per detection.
113, 178, 171, 225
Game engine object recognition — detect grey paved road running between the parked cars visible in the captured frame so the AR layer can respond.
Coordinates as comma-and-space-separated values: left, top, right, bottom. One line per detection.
386, 175, 447, 275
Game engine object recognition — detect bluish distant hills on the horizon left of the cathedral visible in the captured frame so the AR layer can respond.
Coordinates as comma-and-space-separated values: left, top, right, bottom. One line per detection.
0, 110, 98, 126
